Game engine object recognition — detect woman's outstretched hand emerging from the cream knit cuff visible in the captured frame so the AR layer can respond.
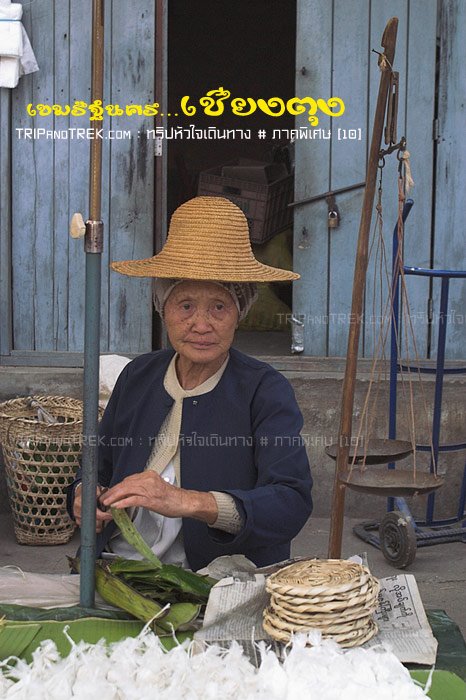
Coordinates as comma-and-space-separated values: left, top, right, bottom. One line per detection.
100, 471, 218, 525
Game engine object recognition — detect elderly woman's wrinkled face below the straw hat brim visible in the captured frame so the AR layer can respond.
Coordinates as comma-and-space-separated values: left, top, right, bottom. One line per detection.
164, 281, 238, 364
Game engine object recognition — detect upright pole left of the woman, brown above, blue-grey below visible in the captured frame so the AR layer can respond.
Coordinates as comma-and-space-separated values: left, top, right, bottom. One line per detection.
80, 0, 104, 607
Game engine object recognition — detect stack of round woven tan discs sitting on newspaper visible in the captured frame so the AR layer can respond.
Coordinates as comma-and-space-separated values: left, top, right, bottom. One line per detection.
263, 559, 380, 647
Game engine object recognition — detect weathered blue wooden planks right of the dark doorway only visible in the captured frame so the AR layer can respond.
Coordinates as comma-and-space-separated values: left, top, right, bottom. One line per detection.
293, 0, 466, 358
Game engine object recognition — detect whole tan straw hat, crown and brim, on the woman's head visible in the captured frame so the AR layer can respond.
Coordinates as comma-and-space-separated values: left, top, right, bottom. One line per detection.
111, 197, 299, 282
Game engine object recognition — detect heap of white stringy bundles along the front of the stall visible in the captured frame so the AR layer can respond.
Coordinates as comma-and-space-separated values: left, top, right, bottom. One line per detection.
0, 630, 425, 700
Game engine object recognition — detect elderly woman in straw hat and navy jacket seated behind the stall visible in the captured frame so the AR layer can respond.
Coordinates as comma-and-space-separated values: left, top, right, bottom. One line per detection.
69, 197, 312, 570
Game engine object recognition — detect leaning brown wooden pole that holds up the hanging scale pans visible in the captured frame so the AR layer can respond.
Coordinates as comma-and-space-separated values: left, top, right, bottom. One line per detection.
328, 17, 398, 559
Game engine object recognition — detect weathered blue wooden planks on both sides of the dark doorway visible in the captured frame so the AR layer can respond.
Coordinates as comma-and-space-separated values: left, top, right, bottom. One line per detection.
0, 0, 466, 365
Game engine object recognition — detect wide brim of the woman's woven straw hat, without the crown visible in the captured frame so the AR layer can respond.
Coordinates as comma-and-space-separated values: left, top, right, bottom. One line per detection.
110, 251, 299, 282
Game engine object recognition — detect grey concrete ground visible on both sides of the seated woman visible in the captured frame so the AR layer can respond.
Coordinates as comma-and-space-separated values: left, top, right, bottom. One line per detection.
0, 514, 466, 638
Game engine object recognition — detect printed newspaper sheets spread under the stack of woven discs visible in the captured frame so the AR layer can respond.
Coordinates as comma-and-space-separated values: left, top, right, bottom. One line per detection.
194, 569, 437, 665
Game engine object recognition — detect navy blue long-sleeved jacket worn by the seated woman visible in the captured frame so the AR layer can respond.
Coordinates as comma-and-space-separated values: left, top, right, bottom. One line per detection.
70, 348, 312, 570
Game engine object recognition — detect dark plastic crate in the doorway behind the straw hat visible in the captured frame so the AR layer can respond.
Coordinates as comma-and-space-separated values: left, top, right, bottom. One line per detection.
197, 162, 293, 243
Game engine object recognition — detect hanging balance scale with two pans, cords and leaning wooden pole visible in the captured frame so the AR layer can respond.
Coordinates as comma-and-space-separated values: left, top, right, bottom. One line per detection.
326, 17, 443, 559
